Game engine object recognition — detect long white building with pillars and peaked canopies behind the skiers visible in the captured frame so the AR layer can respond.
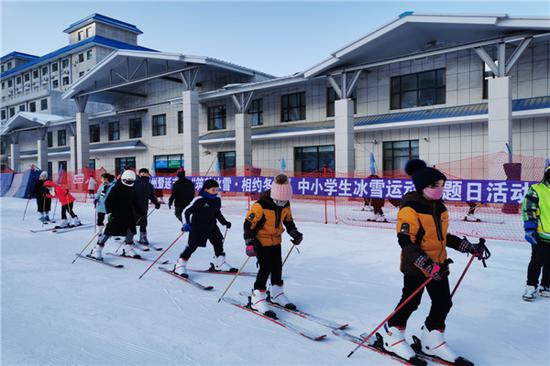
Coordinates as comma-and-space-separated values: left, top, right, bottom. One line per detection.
2, 12, 550, 178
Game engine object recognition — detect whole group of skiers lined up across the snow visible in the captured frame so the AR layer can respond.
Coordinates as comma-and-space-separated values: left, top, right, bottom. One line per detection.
29, 159, 550, 365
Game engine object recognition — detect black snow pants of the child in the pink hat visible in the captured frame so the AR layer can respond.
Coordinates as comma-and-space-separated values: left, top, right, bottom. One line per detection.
254, 244, 283, 291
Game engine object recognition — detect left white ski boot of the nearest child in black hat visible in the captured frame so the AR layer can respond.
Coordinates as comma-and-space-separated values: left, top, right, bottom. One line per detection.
378, 323, 428, 366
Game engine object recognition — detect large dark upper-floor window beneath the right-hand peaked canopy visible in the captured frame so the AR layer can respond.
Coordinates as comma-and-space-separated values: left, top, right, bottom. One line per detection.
391, 69, 445, 109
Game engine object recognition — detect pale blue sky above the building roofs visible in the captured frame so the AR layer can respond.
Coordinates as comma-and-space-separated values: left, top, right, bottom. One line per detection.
0, 0, 550, 76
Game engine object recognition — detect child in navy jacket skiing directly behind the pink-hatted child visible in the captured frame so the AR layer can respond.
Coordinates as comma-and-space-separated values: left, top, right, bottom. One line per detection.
174, 179, 237, 277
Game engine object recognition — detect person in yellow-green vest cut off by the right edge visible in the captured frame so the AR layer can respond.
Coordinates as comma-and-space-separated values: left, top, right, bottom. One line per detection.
522, 166, 550, 301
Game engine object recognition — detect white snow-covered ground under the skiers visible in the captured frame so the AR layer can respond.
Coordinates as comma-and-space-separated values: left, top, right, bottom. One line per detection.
0, 198, 550, 365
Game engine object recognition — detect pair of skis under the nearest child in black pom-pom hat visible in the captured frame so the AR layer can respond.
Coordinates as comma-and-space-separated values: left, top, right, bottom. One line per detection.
332, 329, 473, 366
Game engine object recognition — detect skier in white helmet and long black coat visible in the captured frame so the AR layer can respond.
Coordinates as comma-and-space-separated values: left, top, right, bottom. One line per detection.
90, 170, 143, 260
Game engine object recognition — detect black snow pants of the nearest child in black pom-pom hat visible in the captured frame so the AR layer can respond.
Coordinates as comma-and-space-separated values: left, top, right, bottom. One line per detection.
388, 276, 453, 331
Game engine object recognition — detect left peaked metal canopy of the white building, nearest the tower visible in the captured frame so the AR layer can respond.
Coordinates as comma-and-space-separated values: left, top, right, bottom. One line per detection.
63, 50, 271, 104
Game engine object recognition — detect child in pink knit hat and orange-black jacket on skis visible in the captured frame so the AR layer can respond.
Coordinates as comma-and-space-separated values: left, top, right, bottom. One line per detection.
244, 174, 303, 317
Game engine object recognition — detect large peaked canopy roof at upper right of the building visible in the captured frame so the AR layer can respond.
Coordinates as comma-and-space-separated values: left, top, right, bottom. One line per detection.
304, 12, 550, 78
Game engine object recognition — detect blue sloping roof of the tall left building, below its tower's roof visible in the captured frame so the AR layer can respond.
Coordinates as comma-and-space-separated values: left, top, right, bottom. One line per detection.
0, 36, 157, 78
